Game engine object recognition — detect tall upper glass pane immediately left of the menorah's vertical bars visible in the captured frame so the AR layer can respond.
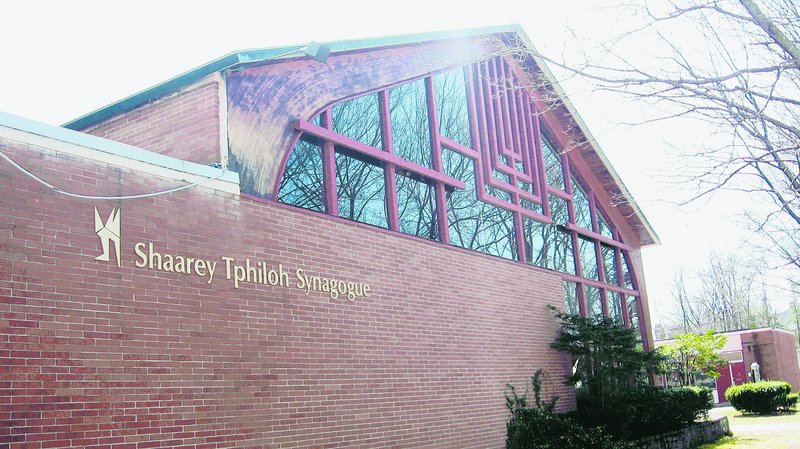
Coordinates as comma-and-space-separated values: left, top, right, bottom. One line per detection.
433, 69, 472, 148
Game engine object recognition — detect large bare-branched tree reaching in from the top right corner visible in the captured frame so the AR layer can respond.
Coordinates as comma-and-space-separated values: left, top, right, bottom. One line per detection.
506, 0, 800, 270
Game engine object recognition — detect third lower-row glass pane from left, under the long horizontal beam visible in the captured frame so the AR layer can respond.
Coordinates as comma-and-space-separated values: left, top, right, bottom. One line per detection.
396, 175, 439, 240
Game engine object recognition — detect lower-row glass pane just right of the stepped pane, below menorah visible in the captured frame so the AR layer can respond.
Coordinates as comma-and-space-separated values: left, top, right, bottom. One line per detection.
522, 217, 575, 274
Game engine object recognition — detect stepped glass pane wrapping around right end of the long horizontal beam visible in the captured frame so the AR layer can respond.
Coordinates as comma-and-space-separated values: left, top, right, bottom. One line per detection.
442, 149, 516, 259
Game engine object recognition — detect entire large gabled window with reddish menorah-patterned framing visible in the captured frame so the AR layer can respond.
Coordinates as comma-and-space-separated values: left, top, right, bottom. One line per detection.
277, 57, 640, 326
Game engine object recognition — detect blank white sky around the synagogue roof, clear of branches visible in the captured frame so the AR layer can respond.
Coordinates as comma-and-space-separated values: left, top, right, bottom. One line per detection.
0, 0, 783, 323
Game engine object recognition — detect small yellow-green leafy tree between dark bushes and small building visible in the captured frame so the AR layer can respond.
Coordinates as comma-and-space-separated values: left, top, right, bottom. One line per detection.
658, 330, 728, 386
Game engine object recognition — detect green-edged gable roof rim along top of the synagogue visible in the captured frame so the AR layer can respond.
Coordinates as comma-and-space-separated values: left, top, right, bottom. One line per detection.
63, 24, 660, 246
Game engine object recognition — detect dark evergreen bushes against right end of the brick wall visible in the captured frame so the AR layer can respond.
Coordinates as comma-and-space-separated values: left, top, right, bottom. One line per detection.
506, 307, 712, 442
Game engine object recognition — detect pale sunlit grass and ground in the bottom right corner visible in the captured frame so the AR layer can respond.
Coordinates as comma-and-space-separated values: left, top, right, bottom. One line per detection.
698, 407, 800, 449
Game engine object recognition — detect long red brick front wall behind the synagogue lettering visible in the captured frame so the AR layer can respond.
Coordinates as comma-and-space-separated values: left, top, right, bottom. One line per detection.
0, 141, 574, 449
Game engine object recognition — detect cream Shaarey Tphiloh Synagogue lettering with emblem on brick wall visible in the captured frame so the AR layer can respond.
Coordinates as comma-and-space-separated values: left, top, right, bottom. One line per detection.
94, 207, 372, 301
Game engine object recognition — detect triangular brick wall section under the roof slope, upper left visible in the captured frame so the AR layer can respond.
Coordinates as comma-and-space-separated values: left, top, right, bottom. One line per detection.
83, 81, 220, 164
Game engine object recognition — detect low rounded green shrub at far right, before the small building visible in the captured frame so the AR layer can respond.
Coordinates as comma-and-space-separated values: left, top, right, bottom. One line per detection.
725, 380, 797, 415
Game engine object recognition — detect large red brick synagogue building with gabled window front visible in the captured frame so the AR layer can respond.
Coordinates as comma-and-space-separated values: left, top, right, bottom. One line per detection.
0, 26, 658, 449
